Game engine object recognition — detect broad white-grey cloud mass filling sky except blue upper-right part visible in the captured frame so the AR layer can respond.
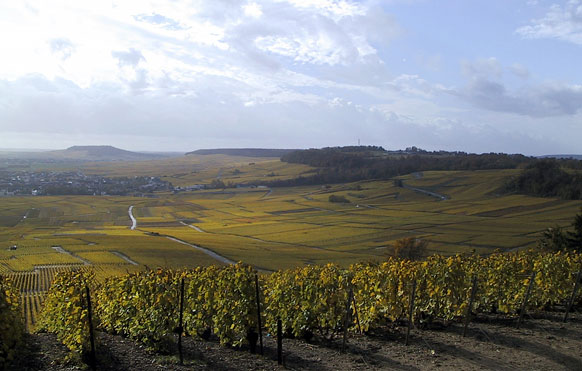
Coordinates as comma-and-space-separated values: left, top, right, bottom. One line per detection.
0, 0, 582, 155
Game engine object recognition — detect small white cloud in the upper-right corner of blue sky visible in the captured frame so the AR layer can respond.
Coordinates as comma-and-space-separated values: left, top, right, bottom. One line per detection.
516, 0, 582, 45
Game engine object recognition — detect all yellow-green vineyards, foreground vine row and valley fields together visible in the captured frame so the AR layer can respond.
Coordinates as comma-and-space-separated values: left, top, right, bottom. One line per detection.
0, 157, 582, 370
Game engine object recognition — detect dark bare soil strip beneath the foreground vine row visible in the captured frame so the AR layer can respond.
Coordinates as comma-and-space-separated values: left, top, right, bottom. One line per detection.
11, 312, 582, 371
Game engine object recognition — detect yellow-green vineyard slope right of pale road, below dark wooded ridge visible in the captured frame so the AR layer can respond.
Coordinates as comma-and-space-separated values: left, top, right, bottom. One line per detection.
116, 171, 580, 269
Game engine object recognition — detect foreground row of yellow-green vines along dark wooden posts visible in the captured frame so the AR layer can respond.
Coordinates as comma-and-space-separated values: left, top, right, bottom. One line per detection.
32, 252, 582, 366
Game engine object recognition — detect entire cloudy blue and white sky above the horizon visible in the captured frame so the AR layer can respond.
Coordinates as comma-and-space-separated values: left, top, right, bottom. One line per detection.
0, 0, 582, 155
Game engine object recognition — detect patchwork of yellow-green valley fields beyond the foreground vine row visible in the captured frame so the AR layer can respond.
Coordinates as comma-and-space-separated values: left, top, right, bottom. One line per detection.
0, 156, 581, 330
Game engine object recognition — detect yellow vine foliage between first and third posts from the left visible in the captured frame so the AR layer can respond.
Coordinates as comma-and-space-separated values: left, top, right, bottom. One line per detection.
96, 263, 257, 349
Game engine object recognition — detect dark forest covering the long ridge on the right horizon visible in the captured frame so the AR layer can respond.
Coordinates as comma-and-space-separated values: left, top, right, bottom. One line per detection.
267, 146, 582, 200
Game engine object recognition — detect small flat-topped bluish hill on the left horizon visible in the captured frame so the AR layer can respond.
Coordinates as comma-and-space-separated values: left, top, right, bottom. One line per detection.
46, 146, 167, 161
